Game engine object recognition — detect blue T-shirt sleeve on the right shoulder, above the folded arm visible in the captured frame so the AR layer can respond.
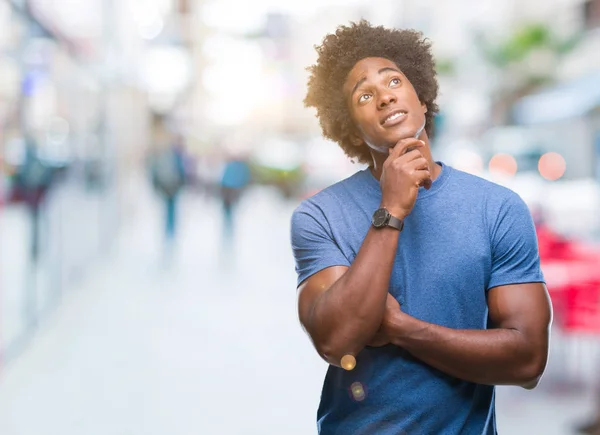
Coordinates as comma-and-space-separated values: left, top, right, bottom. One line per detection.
487, 192, 544, 290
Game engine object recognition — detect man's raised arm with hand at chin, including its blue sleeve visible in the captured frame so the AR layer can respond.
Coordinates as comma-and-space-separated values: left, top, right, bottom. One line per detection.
292, 139, 430, 366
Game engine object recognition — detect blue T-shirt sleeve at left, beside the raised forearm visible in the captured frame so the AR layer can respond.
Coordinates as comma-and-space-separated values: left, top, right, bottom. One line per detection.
291, 205, 350, 285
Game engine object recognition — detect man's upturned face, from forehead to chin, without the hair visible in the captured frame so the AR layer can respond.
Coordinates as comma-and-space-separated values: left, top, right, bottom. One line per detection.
344, 57, 426, 153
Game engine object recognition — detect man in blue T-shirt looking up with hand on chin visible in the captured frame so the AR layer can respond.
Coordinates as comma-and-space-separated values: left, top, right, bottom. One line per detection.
291, 21, 551, 435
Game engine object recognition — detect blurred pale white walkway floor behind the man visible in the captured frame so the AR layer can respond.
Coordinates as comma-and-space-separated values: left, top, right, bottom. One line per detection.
0, 191, 590, 435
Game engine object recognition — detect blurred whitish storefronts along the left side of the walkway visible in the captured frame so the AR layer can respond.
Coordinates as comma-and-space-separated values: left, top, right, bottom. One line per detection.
0, 0, 197, 368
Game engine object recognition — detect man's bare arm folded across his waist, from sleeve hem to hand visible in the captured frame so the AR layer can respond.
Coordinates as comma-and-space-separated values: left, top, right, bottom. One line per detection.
382, 283, 552, 388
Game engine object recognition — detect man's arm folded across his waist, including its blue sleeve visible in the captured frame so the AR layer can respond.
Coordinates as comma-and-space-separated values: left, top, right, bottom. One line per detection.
384, 193, 552, 388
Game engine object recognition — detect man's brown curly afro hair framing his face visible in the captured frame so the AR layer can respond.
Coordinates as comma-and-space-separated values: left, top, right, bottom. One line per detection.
304, 20, 439, 164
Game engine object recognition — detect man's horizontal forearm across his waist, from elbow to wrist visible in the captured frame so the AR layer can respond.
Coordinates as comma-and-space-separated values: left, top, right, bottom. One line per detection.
392, 315, 546, 388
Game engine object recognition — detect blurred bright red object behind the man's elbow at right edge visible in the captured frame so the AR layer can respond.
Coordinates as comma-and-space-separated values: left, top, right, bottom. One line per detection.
537, 224, 600, 334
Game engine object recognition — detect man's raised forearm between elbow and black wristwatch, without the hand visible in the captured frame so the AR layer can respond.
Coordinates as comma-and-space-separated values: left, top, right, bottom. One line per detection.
311, 228, 400, 365
